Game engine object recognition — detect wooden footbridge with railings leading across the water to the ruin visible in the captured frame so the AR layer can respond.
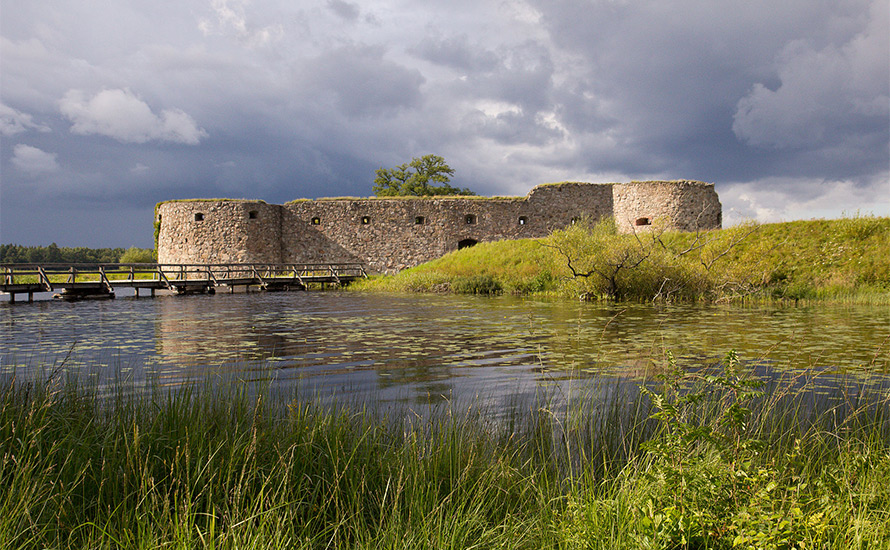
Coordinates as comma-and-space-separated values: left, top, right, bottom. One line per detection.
0, 263, 368, 302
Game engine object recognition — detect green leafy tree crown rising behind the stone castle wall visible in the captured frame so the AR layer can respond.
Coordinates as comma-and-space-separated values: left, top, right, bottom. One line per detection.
374, 155, 476, 197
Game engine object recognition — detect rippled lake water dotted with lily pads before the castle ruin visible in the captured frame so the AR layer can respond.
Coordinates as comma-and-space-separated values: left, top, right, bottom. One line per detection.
0, 292, 890, 410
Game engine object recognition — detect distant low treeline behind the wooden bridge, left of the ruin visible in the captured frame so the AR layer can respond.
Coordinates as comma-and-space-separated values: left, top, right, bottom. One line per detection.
0, 243, 155, 264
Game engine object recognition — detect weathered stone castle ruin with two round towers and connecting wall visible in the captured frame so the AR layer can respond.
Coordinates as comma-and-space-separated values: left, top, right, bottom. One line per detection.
156, 181, 721, 272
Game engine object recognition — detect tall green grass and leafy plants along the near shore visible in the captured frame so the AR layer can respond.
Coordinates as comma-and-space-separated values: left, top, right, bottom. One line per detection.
0, 354, 890, 550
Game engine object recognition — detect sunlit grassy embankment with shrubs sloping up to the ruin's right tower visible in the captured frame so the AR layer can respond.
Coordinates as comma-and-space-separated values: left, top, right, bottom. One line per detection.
355, 216, 890, 304
